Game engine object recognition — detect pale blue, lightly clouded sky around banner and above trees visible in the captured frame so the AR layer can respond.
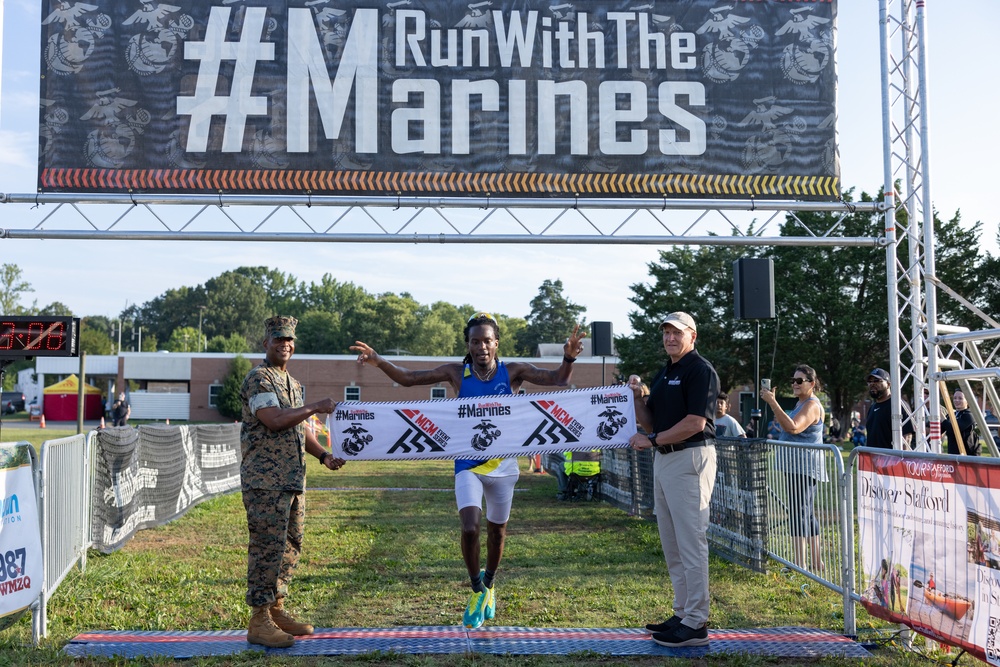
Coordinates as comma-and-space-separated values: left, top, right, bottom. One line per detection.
0, 0, 1000, 334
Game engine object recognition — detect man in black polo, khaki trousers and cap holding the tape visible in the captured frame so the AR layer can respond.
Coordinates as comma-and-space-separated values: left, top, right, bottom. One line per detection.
629, 312, 719, 647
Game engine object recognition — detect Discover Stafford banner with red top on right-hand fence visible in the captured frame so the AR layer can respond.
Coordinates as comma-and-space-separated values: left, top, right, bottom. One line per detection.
857, 453, 1000, 664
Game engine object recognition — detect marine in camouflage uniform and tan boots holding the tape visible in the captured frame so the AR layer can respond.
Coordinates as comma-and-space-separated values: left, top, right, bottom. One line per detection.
240, 317, 344, 647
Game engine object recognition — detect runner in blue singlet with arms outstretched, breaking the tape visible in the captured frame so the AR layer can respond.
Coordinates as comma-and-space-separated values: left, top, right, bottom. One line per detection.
351, 313, 586, 628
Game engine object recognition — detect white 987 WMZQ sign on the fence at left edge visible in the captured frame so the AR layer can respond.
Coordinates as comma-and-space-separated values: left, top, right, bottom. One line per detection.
0, 454, 42, 627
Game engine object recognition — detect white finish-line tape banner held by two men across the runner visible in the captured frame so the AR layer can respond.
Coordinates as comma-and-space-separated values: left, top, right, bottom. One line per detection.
328, 386, 636, 460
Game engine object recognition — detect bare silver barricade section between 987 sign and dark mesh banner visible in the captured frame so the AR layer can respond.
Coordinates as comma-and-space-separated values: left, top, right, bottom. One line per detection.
31, 431, 95, 646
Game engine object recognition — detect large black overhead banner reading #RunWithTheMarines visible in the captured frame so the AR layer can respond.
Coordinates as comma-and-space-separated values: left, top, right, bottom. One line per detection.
38, 0, 839, 200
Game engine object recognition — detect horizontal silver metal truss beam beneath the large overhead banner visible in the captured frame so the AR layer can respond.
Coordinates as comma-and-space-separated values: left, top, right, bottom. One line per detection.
0, 194, 885, 247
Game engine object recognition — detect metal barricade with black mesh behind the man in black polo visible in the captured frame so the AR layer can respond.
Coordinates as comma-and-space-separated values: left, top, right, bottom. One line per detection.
601, 438, 857, 635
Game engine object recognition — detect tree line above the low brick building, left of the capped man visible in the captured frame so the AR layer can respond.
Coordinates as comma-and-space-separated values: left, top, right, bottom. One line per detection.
0, 264, 587, 357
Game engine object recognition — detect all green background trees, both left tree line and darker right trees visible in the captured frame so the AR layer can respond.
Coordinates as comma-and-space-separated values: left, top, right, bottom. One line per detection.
0, 185, 1000, 430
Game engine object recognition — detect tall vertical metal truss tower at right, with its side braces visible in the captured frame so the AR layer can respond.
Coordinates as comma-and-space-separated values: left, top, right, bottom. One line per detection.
879, 0, 1000, 456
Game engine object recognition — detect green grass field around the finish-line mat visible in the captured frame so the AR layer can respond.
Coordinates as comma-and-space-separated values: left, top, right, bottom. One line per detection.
0, 423, 978, 667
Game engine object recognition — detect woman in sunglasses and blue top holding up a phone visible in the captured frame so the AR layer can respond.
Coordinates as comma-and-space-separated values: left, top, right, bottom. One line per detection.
760, 364, 828, 572
